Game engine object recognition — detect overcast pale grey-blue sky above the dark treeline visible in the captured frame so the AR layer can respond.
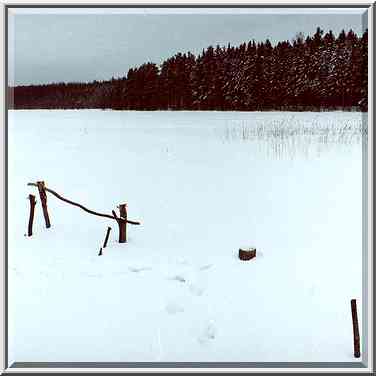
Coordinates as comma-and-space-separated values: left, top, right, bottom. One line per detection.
8, 9, 365, 85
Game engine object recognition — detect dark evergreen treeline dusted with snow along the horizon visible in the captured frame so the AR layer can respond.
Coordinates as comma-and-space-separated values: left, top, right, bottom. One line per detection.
9, 28, 368, 111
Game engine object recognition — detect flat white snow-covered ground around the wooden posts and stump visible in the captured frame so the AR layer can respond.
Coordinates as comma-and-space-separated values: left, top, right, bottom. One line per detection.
9, 110, 362, 362
